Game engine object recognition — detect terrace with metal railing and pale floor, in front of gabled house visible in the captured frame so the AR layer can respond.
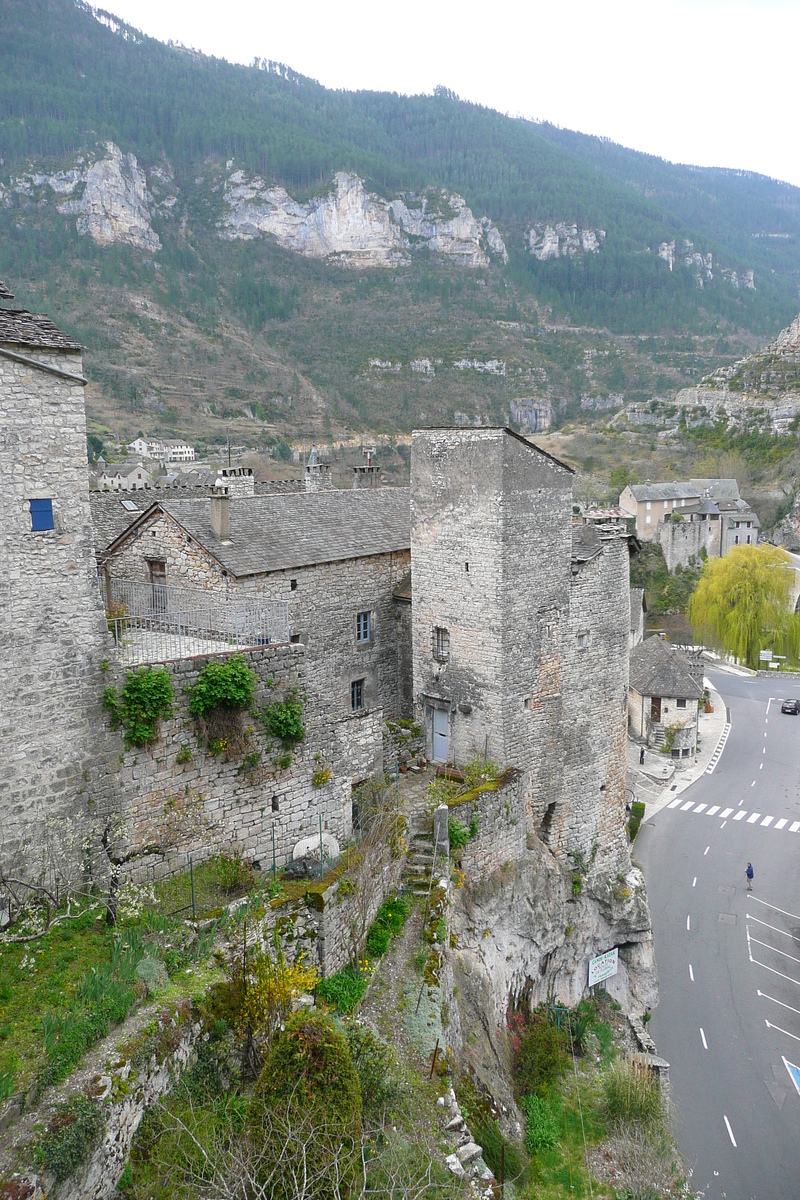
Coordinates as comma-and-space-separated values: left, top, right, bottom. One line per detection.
101, 576, 289, 666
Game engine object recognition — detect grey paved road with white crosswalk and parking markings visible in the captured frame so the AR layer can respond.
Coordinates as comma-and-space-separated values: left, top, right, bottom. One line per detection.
634, 672, 800, 1200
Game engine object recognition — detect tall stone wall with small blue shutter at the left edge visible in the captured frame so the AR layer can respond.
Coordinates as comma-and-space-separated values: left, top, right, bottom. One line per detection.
0, 349, 120, 857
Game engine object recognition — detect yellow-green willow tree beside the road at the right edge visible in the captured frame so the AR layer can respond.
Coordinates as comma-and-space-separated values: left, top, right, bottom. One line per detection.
688, 546, 800, 667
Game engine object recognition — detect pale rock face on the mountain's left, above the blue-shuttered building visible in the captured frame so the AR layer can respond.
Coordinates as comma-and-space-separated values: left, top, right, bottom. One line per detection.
58, 142, 161, 253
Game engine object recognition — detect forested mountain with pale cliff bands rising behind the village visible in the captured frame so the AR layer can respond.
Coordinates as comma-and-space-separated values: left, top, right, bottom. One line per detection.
0, 0, 800, 451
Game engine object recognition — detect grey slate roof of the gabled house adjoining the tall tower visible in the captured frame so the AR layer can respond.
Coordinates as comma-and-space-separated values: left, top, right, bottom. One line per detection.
136, 487, 411, 577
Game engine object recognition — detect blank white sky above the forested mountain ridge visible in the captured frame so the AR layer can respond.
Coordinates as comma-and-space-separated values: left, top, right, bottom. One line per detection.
94, 0, 800, 186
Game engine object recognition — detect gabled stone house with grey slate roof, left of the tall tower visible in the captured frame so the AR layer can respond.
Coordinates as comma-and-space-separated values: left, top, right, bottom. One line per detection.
101, 487, 410, 716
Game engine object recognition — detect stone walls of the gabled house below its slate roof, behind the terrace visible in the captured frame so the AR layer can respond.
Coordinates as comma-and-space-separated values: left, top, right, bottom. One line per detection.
104, 509, 410, 716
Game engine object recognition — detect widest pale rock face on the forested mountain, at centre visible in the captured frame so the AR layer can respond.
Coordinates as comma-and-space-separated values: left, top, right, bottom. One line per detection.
219, 170, 509, 268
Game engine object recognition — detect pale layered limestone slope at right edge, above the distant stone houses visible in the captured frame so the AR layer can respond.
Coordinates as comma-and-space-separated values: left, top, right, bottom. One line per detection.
675, 316, 800, 433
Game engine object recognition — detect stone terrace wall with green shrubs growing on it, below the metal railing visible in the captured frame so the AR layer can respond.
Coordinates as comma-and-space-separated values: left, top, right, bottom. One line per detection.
118, 646, 383, 878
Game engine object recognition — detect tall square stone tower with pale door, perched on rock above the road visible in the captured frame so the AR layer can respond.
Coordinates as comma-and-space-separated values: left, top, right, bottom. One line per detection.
411, 428, 630, 869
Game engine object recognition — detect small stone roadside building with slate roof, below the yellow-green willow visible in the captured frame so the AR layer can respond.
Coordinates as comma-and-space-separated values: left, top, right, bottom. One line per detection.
627, 637, 703, 758
